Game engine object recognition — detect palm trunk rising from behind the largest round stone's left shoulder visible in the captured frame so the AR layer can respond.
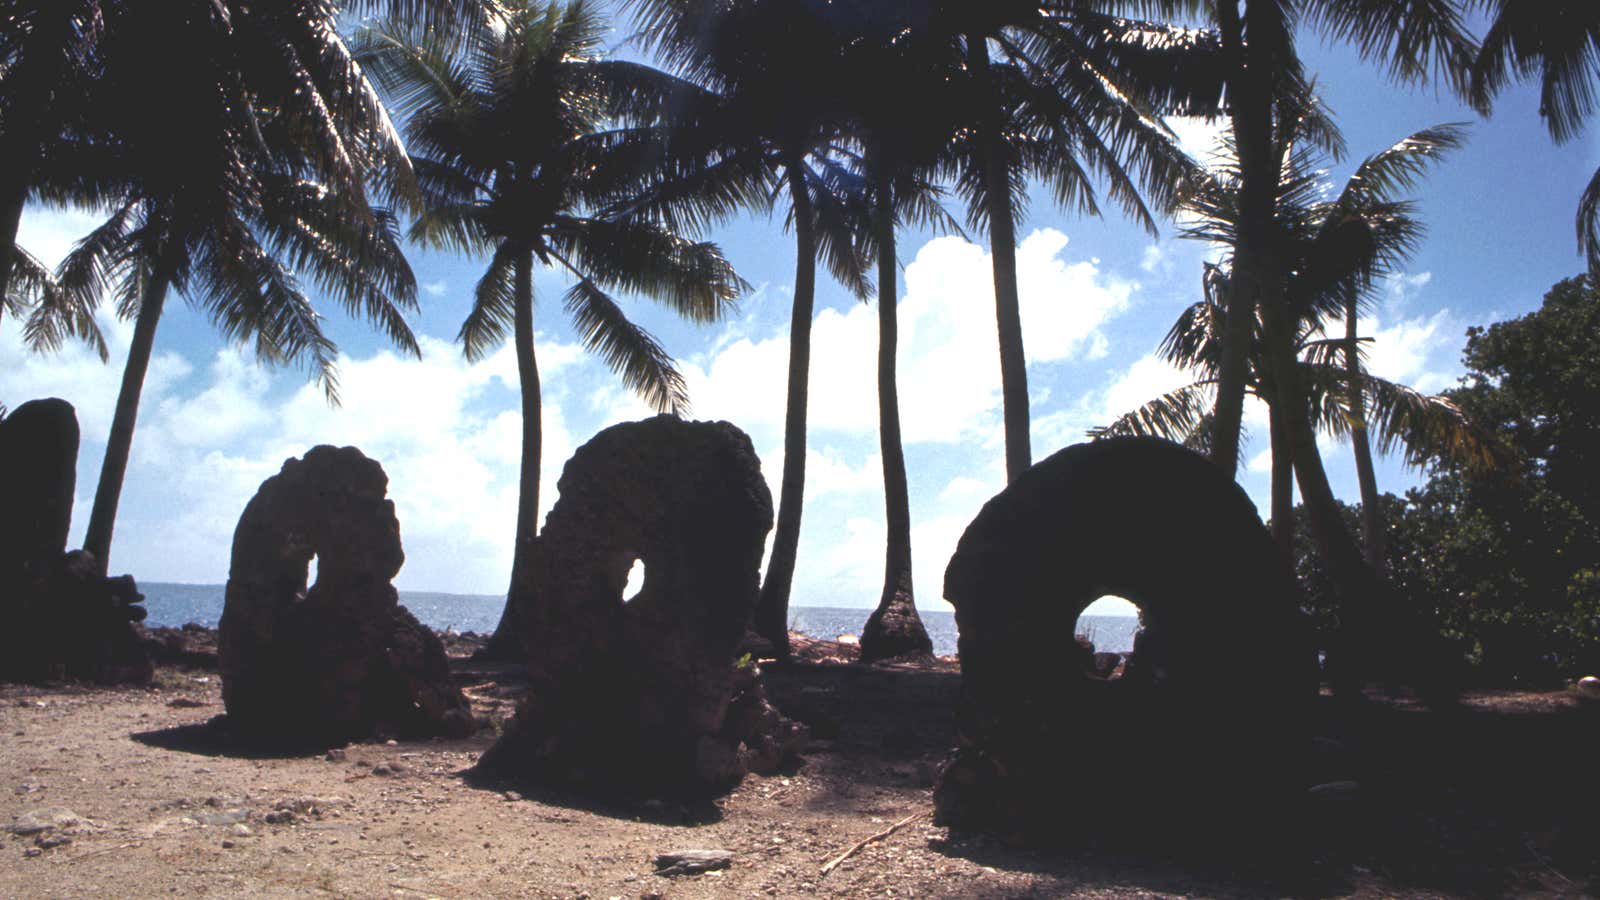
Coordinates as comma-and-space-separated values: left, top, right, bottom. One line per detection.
966, 35, 1034, 482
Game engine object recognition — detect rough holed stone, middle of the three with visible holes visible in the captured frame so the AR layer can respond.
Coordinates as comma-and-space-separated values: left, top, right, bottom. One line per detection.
482, 416, 802, 793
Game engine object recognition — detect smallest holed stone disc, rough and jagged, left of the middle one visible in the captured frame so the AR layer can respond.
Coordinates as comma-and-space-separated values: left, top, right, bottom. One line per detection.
218, 447, 472, 743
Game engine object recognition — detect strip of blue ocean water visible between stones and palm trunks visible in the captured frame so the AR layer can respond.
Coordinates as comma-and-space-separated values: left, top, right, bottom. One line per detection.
139, 581, 1139, 657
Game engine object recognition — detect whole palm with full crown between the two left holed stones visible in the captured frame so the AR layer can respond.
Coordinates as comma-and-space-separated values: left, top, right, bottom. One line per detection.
358, 0, 746, 657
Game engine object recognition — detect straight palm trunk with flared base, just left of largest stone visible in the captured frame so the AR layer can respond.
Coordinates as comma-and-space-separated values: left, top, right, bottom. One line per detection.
861, 175, 933, 663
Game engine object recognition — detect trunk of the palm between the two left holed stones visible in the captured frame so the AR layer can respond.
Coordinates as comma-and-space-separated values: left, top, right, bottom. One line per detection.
480, 250, 544, 660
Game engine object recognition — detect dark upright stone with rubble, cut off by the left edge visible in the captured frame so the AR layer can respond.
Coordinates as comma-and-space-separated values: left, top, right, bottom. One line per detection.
0, 399, 154, 684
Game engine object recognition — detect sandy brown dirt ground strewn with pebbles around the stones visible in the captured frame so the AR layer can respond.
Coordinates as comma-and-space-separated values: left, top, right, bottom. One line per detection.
0, 630, 1600, 900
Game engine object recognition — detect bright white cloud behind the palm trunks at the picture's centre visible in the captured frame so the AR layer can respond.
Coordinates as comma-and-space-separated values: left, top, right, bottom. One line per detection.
683, 229, 1138, 444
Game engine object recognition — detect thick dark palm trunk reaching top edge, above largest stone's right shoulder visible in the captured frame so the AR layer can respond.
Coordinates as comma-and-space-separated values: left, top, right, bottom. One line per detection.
1211, 0, 1278, 474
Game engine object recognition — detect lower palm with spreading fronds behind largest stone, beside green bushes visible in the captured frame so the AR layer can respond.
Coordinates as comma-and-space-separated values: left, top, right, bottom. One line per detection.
1096, 117, 1501, 695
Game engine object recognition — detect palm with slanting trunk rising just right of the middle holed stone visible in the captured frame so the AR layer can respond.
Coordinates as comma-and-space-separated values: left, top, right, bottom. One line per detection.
632, 0, 872, 658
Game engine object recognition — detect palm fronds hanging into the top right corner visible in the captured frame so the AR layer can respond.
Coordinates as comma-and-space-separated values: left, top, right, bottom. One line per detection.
1472, 0, 1600, 275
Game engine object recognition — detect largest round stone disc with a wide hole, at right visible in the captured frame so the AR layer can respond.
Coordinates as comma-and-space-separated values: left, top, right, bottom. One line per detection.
934, 439, 1317, 838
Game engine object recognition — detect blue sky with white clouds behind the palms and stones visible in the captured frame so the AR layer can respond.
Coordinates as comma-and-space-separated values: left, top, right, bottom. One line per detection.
0, 19, 1600, 609
